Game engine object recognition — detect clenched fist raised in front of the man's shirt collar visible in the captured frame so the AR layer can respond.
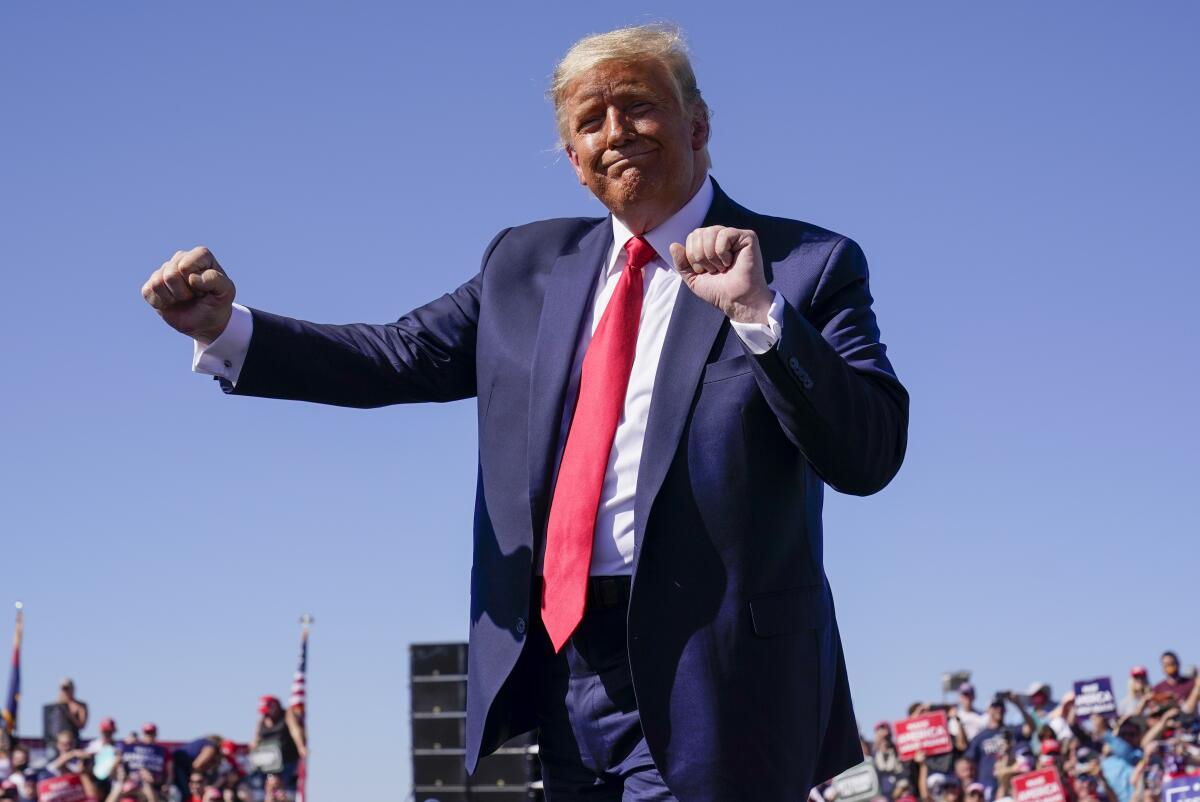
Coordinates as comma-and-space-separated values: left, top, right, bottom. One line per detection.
671, 226, 774, 323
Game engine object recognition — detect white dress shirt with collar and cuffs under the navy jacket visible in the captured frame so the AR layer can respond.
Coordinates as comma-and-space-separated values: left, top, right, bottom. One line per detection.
192, 179, 782, 576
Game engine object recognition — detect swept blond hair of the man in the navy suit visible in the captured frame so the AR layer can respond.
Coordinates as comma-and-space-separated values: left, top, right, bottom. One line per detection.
546, 23, 712, 167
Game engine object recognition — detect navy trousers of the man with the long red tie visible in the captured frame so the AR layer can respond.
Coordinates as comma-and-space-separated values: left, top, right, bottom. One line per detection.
530, 583, 676, 802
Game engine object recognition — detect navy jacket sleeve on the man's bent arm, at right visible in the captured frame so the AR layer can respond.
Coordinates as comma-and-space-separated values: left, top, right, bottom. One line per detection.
748, 238, 908, 496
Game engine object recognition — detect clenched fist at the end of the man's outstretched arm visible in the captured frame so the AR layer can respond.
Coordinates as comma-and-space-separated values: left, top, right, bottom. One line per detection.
142, 245, 236, 346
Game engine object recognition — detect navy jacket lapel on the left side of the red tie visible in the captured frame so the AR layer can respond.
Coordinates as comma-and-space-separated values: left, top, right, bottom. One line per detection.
529, 217, 612, 539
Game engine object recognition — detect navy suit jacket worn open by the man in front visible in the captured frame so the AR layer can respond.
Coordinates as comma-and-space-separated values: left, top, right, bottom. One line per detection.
226, 181, 908, 802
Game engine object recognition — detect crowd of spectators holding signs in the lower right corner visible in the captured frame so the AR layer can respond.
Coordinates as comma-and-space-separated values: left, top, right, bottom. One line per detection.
840, 652, 1200, 802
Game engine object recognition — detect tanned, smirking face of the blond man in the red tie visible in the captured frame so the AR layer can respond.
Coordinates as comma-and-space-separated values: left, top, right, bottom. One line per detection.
563, 61, 708, 228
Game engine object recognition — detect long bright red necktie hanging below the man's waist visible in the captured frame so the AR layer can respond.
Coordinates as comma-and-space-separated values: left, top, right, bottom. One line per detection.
541, 237, 654, 652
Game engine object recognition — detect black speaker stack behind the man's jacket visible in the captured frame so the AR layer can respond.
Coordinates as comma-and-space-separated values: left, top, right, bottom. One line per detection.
409, 644, 545, 802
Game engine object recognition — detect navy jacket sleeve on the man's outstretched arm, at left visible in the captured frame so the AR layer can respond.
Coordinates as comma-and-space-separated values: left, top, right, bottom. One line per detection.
221, 231, 508, 408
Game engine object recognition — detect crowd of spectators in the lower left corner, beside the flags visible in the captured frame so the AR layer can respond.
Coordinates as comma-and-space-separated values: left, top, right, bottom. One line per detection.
0, 680, 306, 802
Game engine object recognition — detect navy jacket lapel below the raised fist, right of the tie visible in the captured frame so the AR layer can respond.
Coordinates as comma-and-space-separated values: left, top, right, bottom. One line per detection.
634, 180, 738, 555
